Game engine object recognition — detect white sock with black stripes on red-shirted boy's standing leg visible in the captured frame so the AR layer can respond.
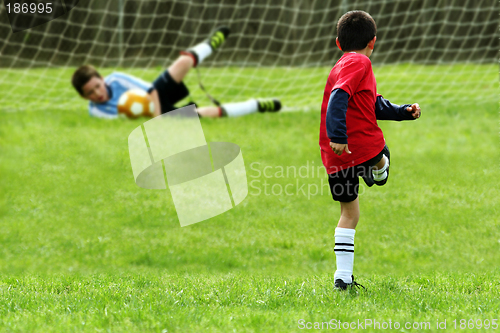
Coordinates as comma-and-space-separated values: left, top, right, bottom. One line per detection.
333, 227, 356, 283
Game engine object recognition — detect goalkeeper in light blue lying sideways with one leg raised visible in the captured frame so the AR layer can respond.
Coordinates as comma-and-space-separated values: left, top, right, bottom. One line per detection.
71, 27, 281, 118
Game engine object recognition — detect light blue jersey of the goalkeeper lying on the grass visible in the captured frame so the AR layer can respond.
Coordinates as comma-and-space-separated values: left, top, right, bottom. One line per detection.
89, 72, 153, 119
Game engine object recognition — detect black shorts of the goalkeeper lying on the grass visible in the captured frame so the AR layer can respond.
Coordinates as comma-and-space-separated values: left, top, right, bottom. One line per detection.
150, 70, 189, 113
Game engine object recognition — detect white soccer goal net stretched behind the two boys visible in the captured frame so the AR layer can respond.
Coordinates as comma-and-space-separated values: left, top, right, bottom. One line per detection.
0, 0, 499, 111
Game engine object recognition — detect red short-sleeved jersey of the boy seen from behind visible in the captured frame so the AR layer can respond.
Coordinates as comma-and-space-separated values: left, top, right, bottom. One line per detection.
319, 53, 385, 174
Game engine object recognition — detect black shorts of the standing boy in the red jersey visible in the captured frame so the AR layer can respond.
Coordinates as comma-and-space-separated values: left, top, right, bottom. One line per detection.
328, 146, 390, 202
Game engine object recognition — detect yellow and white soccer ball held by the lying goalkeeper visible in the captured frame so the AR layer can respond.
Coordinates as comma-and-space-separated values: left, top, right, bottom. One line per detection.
118, 89, 155, 118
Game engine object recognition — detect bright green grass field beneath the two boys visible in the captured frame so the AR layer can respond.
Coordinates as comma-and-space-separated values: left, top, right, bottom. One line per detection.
0, 65, 500, 332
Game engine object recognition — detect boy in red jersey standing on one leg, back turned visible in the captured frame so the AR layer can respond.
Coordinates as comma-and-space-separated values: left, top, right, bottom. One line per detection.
319, 11, 420, 290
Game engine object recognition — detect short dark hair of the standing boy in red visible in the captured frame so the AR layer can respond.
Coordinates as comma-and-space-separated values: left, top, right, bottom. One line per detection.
337, 10, 377, 52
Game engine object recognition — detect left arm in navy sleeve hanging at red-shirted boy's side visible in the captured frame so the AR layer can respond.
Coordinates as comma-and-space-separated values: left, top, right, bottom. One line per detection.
326, 88, 351, 156
